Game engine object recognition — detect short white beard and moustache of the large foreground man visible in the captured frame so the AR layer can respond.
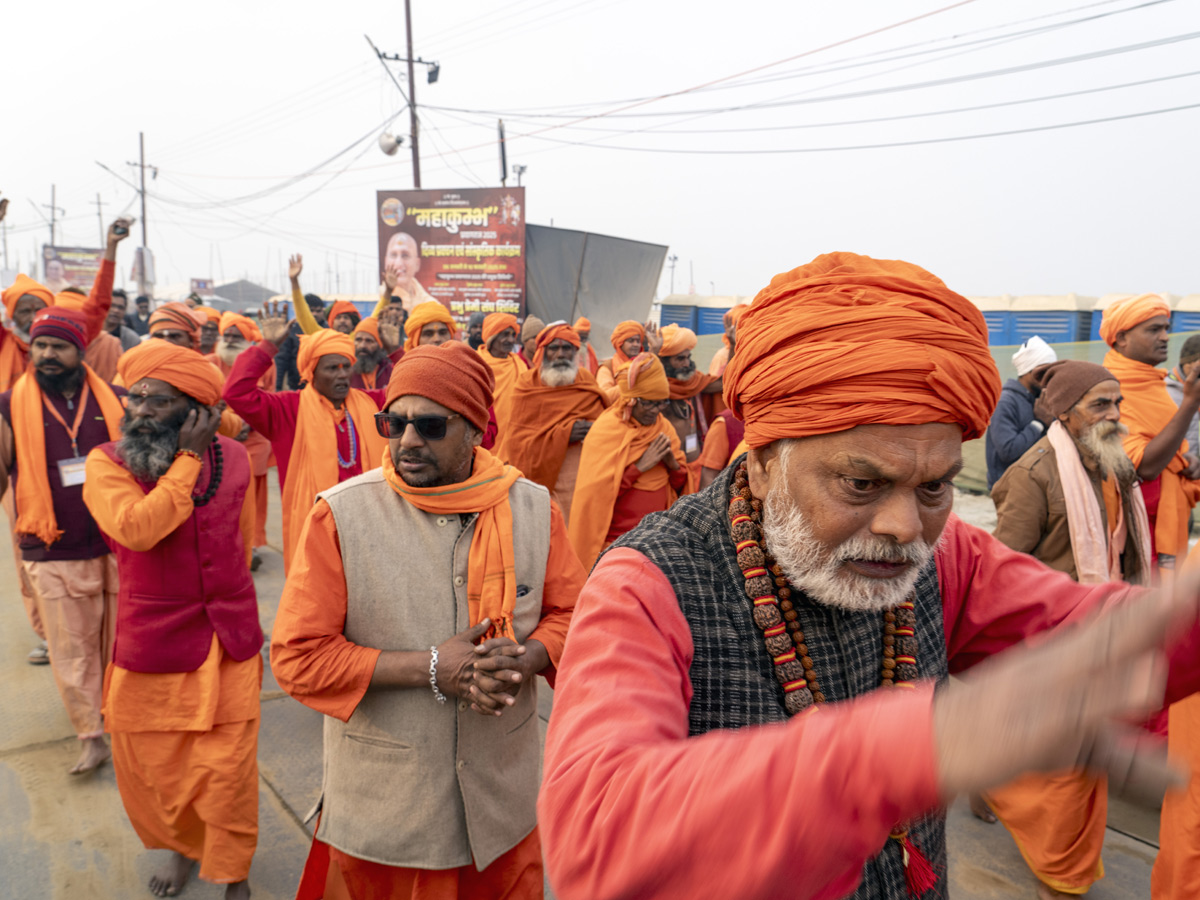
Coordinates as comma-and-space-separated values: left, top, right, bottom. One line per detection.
762, 487, 934, 612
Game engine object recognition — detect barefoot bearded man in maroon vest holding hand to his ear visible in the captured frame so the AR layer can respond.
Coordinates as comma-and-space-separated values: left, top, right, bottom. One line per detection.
83, 341, 263, 900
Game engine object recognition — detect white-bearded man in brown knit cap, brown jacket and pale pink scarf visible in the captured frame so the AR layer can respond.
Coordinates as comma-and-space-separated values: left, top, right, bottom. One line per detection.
972, 360, 1152, 898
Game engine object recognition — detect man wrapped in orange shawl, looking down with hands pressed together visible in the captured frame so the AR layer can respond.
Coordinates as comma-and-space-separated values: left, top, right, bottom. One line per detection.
570, 353, 695, 569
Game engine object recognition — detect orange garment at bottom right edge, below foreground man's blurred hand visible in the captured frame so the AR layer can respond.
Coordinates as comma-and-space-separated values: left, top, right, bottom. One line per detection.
1150, 694, 1200, 900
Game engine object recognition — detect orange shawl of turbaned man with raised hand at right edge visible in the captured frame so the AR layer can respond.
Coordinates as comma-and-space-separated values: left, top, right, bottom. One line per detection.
1104, 350, 1200, 557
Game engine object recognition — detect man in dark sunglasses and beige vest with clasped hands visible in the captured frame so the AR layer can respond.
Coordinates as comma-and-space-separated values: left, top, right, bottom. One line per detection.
271, 342, 584, 900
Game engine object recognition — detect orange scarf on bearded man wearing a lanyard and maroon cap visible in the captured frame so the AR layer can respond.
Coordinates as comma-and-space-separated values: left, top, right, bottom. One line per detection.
12, 364, 125, 545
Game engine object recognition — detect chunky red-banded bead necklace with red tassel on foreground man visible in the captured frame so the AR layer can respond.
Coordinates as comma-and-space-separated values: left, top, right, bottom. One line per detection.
728, 462, 937, 896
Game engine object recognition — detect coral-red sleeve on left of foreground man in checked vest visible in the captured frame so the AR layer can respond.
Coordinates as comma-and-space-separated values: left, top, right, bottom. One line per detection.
538, 548, 938, 900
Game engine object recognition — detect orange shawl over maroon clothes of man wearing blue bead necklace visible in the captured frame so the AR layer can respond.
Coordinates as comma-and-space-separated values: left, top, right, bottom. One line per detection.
282, 384, 388, 572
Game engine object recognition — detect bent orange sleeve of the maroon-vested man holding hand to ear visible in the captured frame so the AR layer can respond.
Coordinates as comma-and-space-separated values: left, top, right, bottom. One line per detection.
83, 448, 200, 553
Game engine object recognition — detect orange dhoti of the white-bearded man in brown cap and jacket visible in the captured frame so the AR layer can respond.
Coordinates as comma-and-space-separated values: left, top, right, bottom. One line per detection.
986, 772, 1104, 896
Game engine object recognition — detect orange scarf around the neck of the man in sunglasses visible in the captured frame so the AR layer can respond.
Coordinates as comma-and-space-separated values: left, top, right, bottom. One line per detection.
383, 446, 521, 641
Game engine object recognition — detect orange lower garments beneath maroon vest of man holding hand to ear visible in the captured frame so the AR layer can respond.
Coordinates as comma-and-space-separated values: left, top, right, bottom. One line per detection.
104, 635, 263, 884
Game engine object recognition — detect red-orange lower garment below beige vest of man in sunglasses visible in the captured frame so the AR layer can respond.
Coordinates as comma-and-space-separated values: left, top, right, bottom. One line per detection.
296, 828, 544, 900
